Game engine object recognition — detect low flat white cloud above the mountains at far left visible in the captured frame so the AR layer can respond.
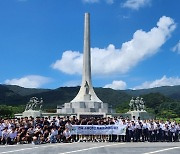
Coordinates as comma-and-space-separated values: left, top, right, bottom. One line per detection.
4, 75, 51, 88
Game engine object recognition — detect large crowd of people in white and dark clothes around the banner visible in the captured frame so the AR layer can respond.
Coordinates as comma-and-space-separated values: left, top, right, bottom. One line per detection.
0, 116, 180, 145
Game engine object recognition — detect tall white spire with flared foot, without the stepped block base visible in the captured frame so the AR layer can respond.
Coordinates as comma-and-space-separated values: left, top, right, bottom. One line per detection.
71, 13, 102, 102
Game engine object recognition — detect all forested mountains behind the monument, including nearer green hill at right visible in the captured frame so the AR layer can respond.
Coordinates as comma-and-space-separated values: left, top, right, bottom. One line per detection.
0, 85, 180, 117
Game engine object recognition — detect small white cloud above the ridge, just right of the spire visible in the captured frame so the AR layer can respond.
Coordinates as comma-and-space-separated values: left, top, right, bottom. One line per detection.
104, 80, 127, 90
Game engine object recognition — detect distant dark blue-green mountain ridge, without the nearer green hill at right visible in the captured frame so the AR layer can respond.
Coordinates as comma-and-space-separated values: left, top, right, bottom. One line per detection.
0, 84, 180, 108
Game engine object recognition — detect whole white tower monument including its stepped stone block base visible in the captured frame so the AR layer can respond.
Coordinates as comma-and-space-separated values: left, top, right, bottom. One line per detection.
59, 13, 108, 114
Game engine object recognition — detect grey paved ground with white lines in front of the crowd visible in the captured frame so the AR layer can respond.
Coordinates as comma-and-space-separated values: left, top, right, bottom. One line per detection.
0, 142, 180, 154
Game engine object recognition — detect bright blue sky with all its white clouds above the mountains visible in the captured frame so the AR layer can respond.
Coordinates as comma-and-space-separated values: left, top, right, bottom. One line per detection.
0, 0, 180, 89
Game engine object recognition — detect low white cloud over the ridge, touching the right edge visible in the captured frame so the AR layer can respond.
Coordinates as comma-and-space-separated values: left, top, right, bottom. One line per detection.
133, 76, 180, 89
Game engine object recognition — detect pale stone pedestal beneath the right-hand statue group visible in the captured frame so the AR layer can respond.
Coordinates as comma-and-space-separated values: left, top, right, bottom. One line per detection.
126, 111, 154, 120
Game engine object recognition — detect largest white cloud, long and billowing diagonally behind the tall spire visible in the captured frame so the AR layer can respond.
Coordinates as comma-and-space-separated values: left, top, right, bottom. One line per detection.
52, 16, 176, 75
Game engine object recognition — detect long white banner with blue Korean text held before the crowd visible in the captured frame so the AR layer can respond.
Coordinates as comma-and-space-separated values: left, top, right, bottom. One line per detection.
71, 125, 126, 135
